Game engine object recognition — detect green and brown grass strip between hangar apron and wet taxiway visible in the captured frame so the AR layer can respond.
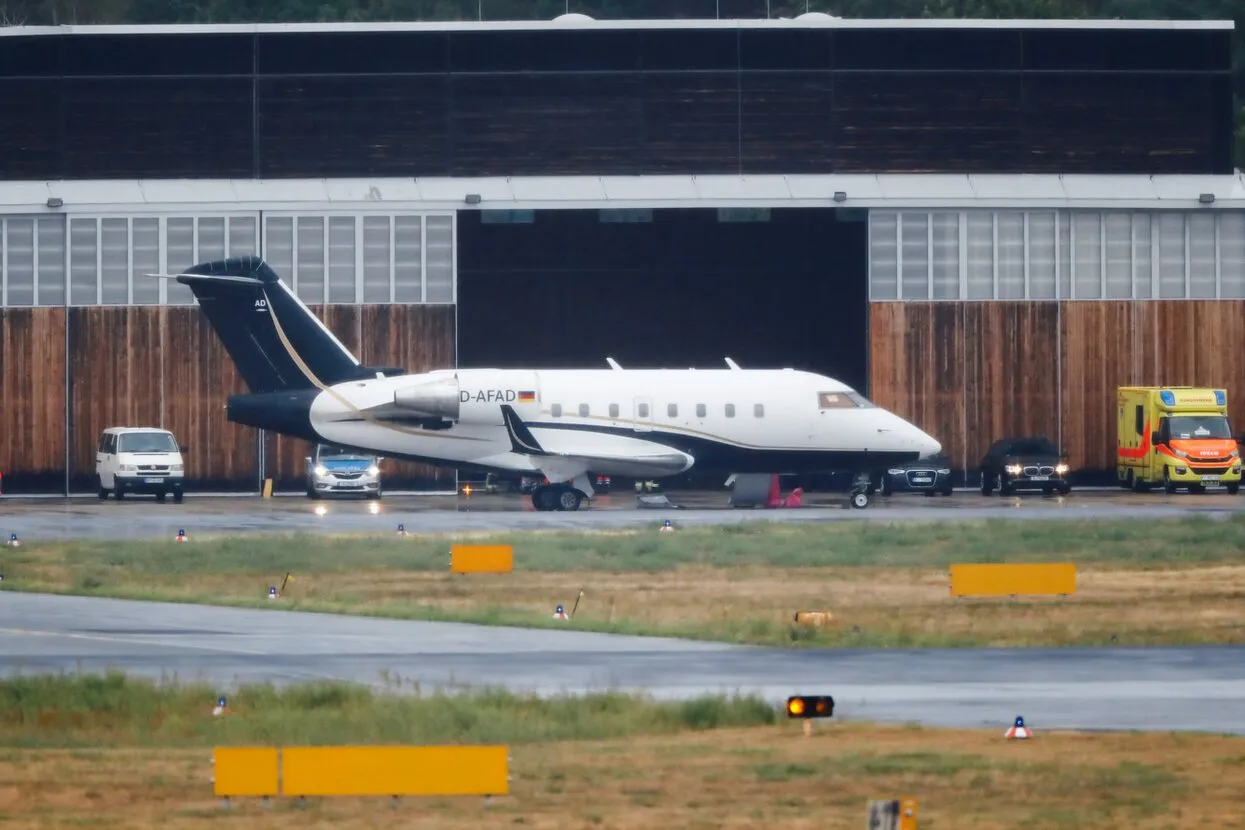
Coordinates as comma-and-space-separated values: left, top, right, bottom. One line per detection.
2, 518, 1245, 647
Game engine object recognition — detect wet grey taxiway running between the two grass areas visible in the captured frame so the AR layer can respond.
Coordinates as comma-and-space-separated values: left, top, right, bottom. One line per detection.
0, 591, 1245, 734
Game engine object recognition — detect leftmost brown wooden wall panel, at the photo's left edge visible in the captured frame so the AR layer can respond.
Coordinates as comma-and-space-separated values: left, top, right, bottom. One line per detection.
0, 309, 65, 494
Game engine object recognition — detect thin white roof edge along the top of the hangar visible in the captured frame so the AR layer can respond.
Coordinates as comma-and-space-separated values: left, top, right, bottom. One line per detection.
0, 12, 1235, 36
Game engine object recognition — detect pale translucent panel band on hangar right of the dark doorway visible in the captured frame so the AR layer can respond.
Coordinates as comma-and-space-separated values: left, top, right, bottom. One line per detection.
869, 210, 1245, 302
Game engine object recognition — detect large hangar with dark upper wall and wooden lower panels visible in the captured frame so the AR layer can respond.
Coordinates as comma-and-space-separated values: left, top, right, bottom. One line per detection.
0, 14, 1245, 493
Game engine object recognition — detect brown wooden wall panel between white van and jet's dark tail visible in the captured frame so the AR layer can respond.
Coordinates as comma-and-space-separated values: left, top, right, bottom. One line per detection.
161, 306, 259, 490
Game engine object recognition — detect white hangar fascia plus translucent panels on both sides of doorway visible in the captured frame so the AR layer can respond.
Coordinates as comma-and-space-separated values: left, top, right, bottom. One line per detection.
0, 172, 1245, 306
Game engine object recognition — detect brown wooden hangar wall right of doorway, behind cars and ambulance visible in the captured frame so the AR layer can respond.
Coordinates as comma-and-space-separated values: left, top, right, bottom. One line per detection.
870, 300, 1245, 484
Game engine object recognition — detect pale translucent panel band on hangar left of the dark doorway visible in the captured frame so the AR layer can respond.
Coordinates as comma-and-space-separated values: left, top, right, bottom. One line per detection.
0, 210, 457, 307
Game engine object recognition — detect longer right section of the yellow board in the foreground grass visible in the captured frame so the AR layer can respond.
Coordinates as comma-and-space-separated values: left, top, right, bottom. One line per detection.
281, 747, 509, 796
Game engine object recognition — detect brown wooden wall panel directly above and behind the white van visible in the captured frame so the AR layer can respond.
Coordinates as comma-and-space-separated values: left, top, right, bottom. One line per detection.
68, 307, 163, 490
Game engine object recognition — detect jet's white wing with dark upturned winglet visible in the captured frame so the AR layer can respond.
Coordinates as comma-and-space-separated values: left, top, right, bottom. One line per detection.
502, 404, 696, 480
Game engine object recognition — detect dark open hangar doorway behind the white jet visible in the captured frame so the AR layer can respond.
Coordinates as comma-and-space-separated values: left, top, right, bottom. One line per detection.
458, 208, 868, 487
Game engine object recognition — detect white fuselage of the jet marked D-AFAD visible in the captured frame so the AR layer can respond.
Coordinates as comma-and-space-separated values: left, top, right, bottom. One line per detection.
301, 368, 940, 480
